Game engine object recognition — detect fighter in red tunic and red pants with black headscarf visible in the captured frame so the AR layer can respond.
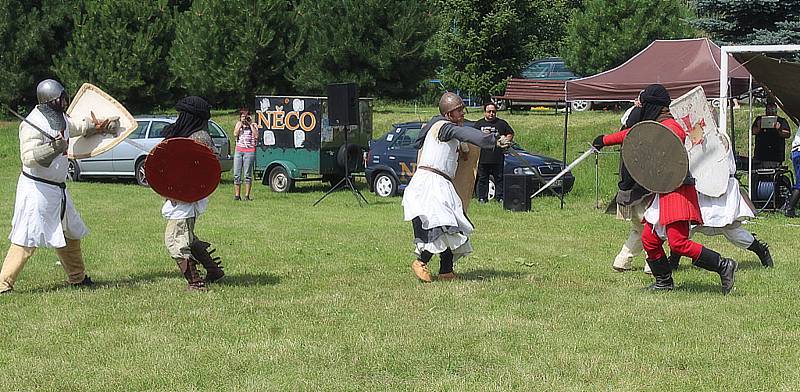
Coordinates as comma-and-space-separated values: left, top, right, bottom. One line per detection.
592, 84, 737, 294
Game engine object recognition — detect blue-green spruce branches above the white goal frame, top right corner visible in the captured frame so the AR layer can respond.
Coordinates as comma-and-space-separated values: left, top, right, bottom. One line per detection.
692, 0, 800, 45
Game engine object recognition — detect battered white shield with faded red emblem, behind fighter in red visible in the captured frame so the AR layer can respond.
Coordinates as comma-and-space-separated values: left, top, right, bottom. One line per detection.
669, 86, 731, 197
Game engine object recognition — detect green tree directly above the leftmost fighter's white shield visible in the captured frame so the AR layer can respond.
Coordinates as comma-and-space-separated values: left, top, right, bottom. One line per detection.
53, 0, 173, 109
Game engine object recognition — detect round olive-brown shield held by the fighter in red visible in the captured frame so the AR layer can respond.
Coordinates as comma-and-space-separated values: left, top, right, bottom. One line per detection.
622, 121, 689, 193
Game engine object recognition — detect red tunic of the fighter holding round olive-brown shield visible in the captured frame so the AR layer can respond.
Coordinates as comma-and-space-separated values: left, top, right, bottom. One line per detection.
603, 118, 703, 226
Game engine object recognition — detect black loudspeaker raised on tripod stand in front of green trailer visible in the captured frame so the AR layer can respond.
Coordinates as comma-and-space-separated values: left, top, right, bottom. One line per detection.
314, 83, 369, 206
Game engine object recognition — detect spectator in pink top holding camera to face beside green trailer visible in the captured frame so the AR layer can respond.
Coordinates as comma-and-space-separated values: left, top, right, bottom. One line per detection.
233, 109, 258, 201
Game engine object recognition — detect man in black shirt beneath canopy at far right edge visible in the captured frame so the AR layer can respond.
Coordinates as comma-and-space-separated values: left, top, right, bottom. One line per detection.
751, 99, 792, 167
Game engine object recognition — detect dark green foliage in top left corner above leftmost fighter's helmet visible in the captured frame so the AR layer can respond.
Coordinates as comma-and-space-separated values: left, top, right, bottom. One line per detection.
0, 0, 81, 111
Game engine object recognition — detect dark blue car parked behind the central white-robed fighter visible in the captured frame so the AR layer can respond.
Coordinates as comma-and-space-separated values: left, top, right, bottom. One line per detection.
364, 122, 575, 199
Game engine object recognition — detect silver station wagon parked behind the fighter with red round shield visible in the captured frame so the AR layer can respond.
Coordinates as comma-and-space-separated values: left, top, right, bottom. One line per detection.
67, 116, 233, 186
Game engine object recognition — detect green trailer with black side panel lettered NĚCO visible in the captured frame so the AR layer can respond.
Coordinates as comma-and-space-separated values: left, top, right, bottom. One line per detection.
255, 95, 372, 192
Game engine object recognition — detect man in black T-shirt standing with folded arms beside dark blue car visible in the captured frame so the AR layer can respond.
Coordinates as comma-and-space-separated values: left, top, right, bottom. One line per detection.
473, 102, 514, 203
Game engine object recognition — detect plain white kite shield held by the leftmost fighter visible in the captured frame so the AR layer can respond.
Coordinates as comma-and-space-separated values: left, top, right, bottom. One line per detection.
67, 83, 139, 159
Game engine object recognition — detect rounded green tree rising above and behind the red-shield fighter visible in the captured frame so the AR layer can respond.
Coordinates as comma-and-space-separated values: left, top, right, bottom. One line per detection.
169, 0, 287, 107
